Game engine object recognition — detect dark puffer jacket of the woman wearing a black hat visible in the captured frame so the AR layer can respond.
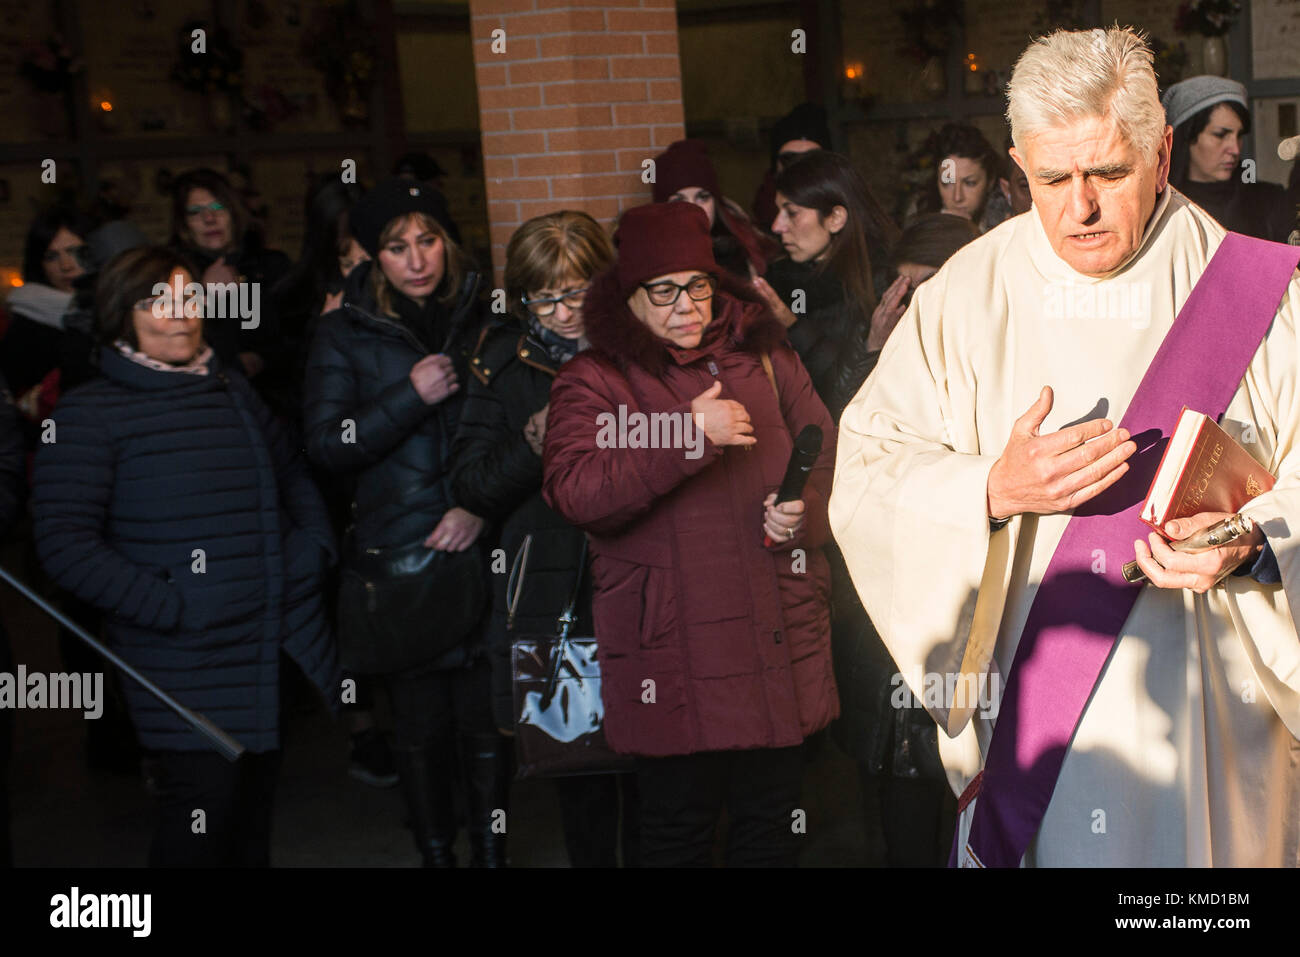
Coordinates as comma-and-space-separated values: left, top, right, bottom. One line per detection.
303, 263, 488, 667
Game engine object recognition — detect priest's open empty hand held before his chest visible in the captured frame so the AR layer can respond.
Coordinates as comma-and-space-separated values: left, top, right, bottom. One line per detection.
988, 386, 1138, 520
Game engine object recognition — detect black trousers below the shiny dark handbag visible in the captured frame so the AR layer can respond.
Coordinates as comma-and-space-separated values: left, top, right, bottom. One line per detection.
555, 774, 641, 867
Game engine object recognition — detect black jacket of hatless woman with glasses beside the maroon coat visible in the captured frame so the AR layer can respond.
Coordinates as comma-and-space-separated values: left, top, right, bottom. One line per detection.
451, 322, 592, 729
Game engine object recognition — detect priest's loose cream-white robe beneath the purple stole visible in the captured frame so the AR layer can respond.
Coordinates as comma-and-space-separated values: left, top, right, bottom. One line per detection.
829, 187, 1300, 867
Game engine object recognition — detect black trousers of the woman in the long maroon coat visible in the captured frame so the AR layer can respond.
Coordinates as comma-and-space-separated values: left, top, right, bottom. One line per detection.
637, 746, 803, 867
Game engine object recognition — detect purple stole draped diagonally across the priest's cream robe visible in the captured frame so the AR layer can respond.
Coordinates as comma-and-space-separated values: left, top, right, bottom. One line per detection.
949, 233, 1300, 867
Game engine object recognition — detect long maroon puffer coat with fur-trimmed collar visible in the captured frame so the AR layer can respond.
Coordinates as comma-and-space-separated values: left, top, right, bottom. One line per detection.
543, 276, 840, 757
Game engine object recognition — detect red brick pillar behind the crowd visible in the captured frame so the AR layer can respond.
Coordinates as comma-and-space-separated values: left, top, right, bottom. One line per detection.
469, 0, 684, 286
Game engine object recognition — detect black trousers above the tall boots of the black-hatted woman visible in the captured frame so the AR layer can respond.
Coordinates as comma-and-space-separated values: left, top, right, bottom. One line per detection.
384, 658, 497, 748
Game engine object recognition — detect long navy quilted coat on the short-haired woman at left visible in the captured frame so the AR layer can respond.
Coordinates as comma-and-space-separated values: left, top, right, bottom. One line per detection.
31, 348, 339, 752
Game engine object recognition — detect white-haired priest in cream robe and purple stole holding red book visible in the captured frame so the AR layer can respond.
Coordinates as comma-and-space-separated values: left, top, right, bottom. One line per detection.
831, 27, 1300, 866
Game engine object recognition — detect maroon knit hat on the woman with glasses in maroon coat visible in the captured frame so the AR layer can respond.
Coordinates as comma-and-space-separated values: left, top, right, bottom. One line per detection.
614, 203, 719, 299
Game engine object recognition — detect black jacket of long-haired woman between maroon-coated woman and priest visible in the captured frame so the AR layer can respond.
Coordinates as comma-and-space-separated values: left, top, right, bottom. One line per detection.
764, 259, 880, 424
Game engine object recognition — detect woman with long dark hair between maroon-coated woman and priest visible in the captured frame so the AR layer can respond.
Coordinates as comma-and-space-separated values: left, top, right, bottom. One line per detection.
754, 150, 898, 420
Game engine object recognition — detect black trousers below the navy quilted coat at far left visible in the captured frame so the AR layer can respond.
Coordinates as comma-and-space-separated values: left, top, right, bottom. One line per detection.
144, 752, 280, 867
